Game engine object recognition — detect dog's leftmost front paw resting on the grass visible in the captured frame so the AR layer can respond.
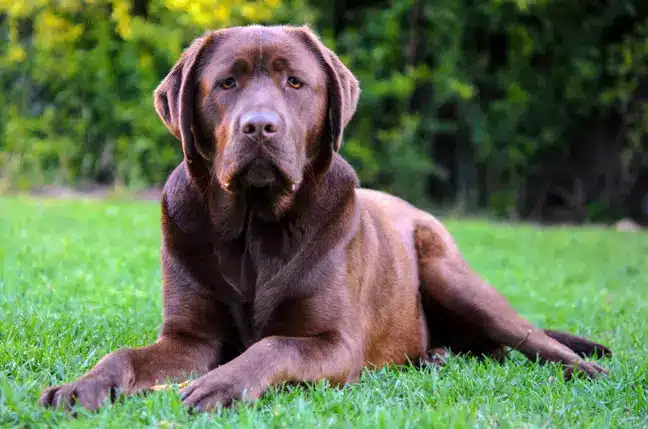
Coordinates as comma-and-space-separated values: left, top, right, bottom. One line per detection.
39, 378, 116, 411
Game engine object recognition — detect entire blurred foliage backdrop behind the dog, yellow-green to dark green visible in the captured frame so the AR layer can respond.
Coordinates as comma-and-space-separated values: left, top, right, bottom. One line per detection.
0, 0, 648, 219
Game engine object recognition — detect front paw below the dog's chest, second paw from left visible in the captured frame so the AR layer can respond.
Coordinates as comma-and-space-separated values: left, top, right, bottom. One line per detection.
180, 368, 261, 411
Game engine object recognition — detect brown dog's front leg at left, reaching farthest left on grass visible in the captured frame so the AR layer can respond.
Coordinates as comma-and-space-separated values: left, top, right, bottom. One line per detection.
40, 252, 229, 410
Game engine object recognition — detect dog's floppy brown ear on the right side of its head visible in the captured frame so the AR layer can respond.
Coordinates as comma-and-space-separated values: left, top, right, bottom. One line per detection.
296, 27, 360, 152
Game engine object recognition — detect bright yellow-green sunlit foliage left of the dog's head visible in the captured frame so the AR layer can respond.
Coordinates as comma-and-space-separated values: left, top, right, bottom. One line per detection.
0, 0, 312, 186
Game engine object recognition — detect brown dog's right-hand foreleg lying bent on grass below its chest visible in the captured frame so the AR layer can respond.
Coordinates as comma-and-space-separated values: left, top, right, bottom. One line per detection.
180, 333, 361, 411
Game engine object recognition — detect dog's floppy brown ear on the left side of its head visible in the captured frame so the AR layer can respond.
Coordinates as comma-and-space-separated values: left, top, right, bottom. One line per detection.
153, 33, 214, 163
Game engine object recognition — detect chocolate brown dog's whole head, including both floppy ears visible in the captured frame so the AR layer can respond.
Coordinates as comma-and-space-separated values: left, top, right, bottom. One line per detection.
155, 26, 359, 213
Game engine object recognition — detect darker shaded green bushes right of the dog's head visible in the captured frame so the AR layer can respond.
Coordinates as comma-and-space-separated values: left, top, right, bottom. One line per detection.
322, 0, 648, 218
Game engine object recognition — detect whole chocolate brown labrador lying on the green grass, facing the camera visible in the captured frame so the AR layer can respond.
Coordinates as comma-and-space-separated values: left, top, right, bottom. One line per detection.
41, 26, 610, 410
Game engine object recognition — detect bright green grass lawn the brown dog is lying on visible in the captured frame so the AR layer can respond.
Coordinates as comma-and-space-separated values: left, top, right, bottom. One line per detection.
0, 198, 648, 428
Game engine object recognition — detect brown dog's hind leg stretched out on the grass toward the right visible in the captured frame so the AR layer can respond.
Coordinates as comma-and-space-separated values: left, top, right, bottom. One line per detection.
415, 221, 607, 377
